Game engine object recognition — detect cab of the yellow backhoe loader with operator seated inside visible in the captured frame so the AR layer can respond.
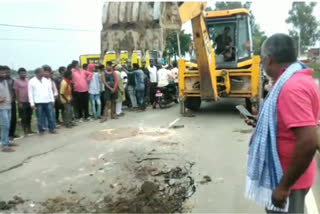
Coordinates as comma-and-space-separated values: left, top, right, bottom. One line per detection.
205, 9, 253, 69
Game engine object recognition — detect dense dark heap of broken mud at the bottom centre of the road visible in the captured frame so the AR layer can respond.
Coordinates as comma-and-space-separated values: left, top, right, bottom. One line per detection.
39, 163, 196, 213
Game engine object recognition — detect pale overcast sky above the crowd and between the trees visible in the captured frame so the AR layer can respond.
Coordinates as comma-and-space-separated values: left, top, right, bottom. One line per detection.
0, 0, 320, 69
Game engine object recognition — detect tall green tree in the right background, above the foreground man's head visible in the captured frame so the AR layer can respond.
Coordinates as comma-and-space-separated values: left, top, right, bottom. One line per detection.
286, 2, 320, 54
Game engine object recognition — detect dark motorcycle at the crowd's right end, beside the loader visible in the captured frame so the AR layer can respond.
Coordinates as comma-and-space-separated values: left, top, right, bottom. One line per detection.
154, 83, 178, 109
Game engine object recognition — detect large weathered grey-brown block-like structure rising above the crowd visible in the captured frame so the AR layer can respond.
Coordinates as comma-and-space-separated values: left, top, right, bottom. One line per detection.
101, 2, 181, 56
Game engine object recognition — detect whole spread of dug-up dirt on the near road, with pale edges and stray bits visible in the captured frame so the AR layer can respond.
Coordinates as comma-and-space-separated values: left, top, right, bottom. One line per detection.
10, 148, 208, 213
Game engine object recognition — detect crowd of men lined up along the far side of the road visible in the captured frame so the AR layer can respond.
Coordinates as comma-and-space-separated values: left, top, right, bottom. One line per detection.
0, 60, 178, 152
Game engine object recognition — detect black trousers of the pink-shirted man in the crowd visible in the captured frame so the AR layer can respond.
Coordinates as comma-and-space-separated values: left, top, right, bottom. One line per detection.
74, 92, 89, 119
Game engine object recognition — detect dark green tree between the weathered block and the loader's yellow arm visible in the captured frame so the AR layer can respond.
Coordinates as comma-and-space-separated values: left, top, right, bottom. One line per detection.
166, 31, 192, 60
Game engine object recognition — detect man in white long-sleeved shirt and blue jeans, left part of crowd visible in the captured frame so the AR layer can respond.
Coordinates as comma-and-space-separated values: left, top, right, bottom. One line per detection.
28, 68, 56, 135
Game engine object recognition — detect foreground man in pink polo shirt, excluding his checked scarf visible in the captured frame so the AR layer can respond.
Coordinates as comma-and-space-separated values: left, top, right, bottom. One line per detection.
247, 34, 320, 213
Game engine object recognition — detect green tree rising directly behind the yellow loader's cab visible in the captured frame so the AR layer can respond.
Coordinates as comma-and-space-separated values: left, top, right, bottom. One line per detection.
215, 1, 267, 55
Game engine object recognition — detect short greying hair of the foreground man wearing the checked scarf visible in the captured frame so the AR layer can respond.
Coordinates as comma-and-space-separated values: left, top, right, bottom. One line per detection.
261, 33, 297, 64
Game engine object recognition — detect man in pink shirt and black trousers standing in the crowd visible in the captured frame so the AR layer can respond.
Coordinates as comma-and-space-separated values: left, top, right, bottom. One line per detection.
72, 60, 93, 121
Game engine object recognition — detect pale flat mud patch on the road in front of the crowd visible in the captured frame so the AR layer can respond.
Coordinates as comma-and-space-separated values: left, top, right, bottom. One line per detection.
90, 127, 170, 141
